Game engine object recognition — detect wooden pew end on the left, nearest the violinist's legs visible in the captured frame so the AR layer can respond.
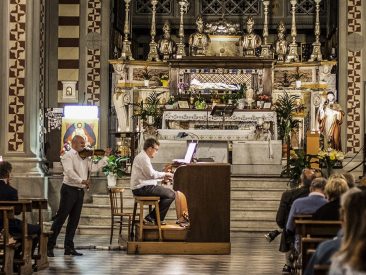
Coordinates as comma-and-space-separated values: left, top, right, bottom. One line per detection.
27, 198, 50, 270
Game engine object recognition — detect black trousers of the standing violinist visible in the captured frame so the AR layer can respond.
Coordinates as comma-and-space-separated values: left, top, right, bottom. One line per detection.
48, 184, 84, 249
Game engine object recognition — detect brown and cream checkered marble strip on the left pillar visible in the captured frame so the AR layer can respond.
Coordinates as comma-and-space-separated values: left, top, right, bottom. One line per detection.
5, 0, 27, 153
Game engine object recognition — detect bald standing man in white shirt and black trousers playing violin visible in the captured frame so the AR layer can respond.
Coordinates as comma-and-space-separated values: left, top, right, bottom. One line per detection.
47, 135, 111, 257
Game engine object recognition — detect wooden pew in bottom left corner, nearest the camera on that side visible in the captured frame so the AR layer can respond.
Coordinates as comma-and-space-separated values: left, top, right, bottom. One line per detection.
0, 200, 33, 274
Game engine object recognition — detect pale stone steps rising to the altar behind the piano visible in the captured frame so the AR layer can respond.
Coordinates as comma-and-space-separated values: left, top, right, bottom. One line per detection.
48, 177, 287, 235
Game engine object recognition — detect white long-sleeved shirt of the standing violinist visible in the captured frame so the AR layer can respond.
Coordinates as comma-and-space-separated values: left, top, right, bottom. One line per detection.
61, 149, 108, 188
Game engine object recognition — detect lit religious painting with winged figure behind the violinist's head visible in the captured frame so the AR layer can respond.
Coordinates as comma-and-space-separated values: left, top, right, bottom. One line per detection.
61, 118, 99, 148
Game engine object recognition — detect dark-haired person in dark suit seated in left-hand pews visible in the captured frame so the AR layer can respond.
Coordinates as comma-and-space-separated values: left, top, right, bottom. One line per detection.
0, 161, 41, 258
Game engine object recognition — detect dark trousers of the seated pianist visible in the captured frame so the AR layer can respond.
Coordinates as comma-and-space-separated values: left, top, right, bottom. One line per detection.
132, 185, 175, 221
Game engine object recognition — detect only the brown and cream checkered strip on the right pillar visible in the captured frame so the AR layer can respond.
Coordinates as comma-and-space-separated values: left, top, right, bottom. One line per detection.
346, 0, 365, 153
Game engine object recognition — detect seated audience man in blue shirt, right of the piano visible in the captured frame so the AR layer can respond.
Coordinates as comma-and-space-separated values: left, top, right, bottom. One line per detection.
286, 178, 328, 232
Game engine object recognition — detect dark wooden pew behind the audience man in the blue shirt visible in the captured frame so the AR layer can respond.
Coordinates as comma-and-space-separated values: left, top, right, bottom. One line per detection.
295, 219, 341, 272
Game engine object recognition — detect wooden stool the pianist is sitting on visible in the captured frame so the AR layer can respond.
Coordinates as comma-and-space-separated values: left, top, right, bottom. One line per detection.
132, 196, 163, 241
